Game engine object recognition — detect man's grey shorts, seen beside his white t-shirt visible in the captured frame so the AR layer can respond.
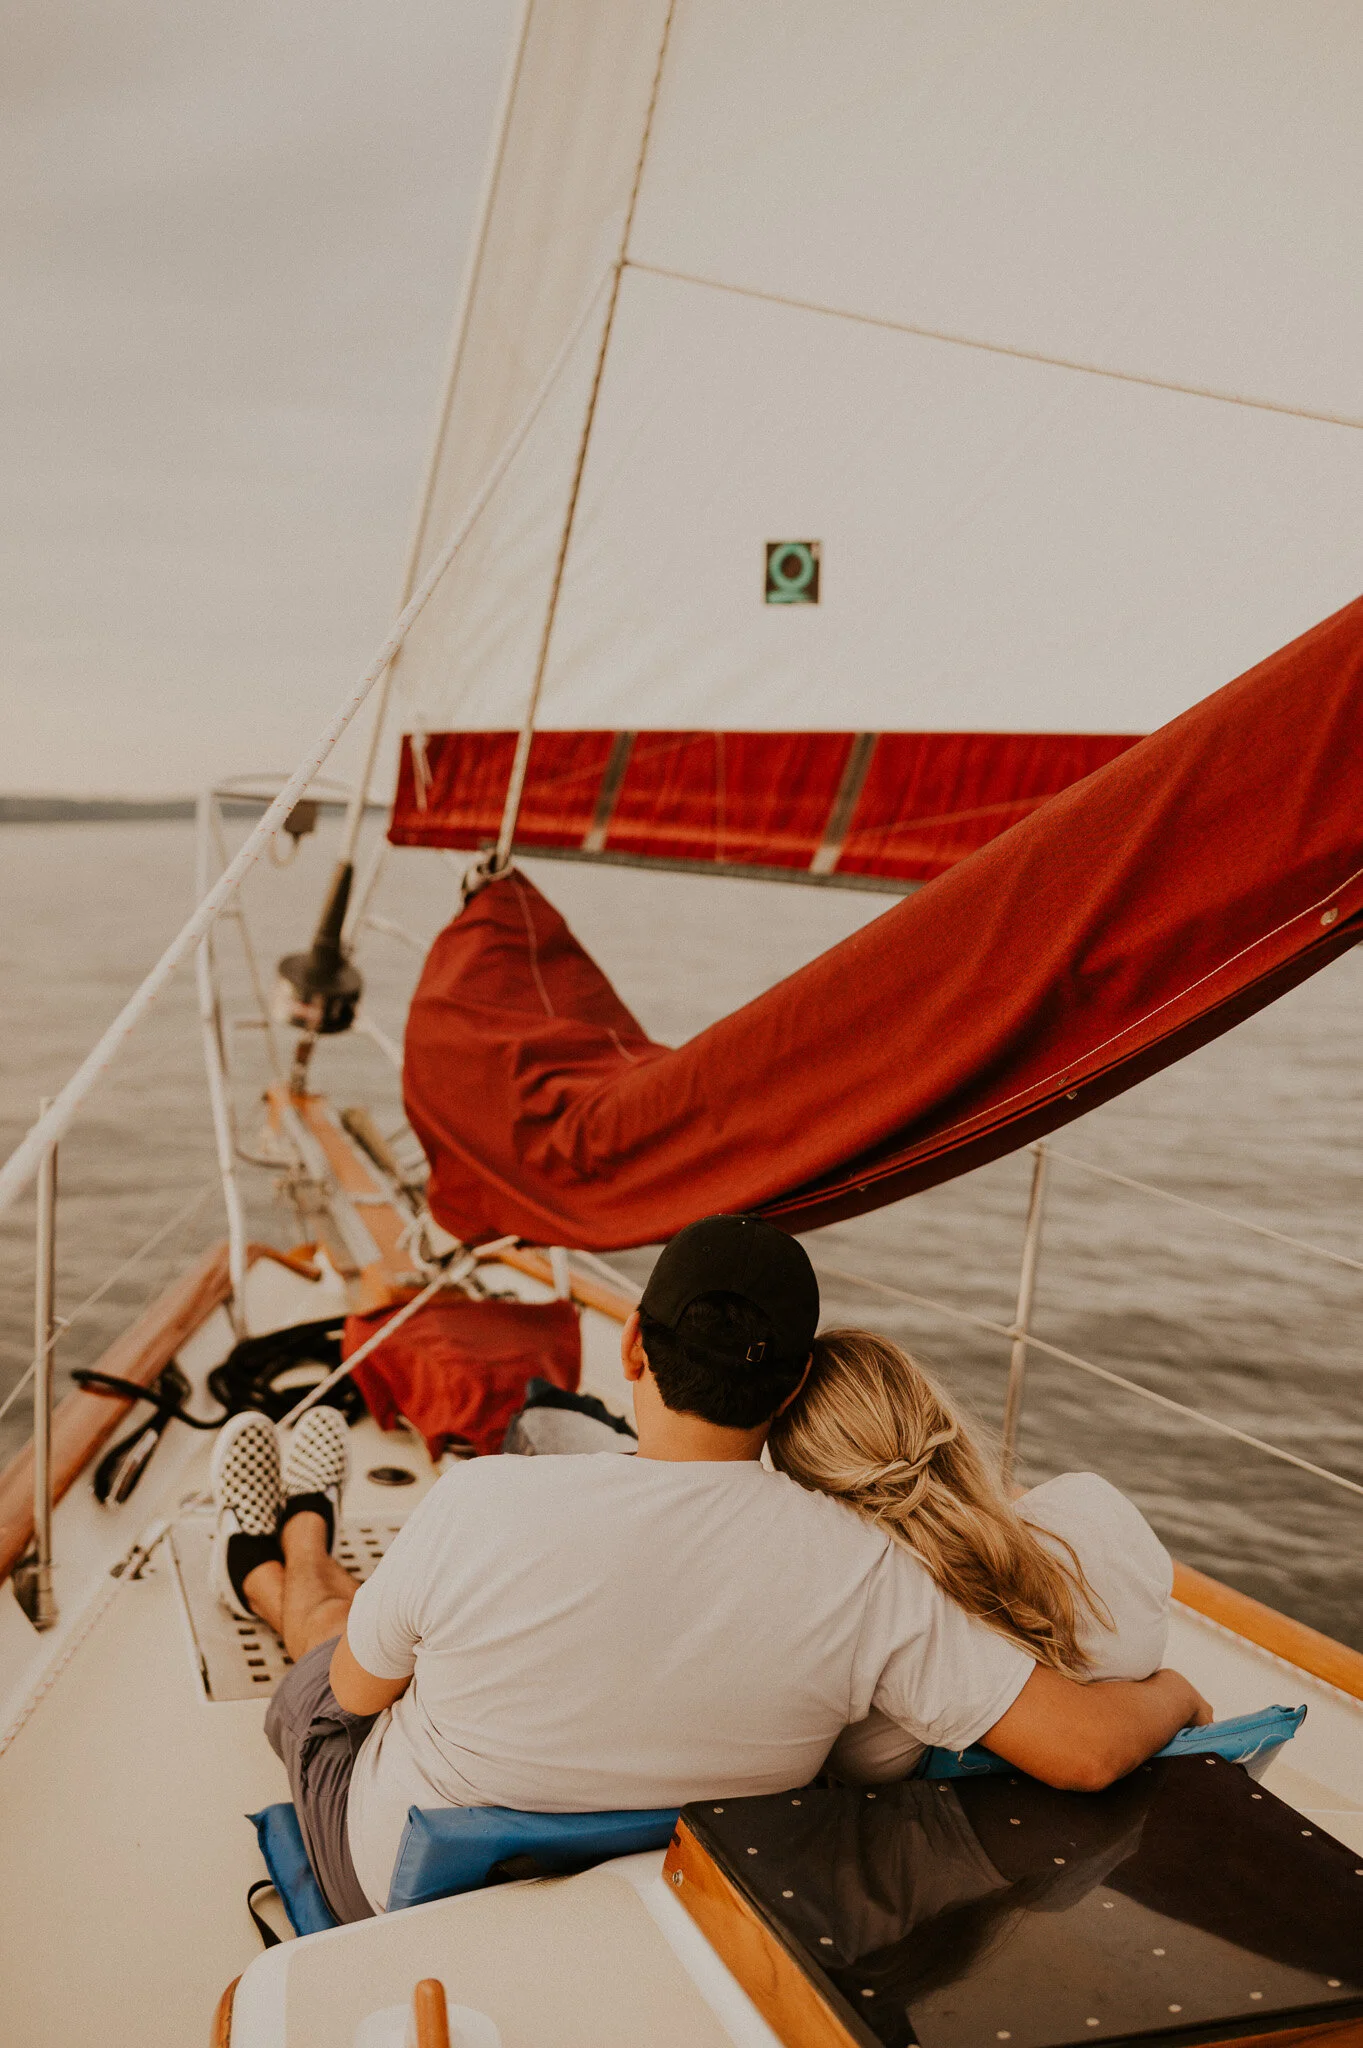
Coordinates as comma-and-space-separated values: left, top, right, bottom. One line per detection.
266, 1636, 379, 1921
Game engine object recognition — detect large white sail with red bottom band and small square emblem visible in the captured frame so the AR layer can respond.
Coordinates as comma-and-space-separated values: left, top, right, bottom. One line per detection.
382, 0, 1363, 885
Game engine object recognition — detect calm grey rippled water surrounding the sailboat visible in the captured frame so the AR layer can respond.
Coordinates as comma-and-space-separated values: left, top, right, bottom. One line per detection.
0, 823, 1363, 1649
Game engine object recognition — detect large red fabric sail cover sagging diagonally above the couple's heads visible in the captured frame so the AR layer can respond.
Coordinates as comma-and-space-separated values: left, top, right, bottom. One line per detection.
405, 600, 1363, 1251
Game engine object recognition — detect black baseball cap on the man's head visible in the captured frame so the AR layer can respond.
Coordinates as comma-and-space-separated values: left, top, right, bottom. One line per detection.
639, 1217, 819, 1364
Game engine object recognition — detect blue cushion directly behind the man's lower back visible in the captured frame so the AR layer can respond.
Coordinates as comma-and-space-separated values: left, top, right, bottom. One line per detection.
389, 1806, 677, 1913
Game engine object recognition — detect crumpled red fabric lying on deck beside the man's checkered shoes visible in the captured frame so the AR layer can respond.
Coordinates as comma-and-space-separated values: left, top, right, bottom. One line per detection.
342, 1294, 581, 1458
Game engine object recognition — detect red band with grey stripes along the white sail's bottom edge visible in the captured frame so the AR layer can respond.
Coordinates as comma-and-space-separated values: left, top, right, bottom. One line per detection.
389, 731, 1136, 889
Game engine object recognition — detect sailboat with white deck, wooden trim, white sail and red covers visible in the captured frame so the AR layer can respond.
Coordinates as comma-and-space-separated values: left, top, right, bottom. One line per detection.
0, 0, 1363, 2048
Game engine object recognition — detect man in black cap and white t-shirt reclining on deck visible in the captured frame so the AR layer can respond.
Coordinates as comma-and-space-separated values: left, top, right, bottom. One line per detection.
219, 1217, 1210, 1919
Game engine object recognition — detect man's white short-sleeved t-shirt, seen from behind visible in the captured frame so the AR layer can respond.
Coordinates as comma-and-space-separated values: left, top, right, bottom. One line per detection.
346, 1452, 1034, 1911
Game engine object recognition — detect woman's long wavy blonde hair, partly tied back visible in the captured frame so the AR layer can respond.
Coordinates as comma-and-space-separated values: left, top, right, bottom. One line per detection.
767, 1329, 1111, 1677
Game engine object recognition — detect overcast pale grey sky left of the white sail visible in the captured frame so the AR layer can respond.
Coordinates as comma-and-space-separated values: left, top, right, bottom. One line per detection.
0, 0, 512, 795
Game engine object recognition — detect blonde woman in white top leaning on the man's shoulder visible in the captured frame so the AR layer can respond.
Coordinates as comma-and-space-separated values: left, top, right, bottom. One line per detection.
767, 1329, 1173, 1784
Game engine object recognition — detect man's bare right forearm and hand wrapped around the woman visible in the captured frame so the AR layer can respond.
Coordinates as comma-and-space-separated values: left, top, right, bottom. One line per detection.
978, 1662, 1212, 1792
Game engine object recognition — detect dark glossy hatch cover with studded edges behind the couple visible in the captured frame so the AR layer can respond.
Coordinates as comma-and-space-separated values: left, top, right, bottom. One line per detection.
684, 1757, 1363, 2048
